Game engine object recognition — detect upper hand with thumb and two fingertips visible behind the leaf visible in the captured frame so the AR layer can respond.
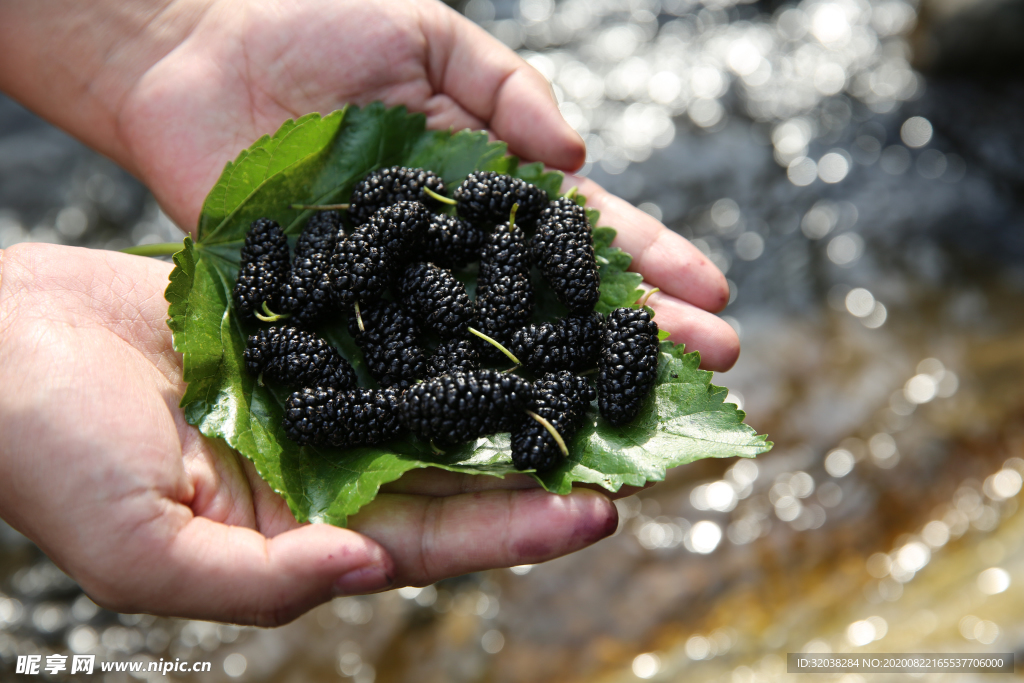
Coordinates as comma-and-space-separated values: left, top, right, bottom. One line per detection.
0, 0, 739, 371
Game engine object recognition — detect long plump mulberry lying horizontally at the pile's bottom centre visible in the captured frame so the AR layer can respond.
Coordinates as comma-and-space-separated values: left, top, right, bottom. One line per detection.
398, 370, 534, 443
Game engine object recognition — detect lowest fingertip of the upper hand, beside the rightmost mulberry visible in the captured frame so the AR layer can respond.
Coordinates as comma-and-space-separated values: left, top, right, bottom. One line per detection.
647, 292, 739, 373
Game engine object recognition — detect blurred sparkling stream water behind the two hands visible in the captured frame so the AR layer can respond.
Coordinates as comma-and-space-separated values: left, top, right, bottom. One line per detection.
0, 0, 1024, 683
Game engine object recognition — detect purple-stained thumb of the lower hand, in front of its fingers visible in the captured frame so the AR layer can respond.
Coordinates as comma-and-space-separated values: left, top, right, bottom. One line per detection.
85, 517, 394, 626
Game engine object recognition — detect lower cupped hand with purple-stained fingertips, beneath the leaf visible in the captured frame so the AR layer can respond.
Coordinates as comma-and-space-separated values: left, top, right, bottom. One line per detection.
0, 245, 617, 626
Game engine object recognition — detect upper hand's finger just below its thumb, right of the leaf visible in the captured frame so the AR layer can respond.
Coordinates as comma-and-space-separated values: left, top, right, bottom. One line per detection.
564, 176, 729, 311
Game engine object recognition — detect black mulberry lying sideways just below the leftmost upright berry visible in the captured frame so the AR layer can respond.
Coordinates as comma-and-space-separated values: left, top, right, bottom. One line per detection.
243, 327, 358, 391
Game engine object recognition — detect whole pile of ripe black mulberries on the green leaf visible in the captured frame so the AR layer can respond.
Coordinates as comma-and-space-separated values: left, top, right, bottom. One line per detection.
233, 166, 658, 471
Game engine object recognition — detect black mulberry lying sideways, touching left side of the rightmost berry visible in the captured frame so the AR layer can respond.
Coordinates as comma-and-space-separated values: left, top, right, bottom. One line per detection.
509, 313, 602, 373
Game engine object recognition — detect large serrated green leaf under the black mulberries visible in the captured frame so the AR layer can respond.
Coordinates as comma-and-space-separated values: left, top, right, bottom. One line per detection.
165, 102, 771, 525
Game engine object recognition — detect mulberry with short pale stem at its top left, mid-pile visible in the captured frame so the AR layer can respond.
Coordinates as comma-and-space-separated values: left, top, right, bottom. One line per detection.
348, 301, 427, 387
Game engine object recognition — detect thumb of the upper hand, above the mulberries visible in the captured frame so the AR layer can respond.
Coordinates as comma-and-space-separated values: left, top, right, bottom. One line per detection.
429, 3, 587, 171
